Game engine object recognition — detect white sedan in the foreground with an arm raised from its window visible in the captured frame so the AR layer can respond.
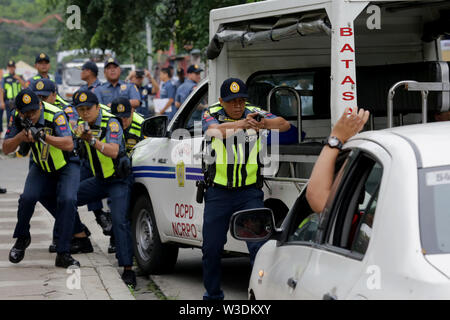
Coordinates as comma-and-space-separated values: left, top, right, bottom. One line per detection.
231, 122, 450, 299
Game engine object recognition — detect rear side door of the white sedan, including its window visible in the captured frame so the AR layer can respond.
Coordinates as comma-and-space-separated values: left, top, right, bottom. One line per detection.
296, 142, 389, 300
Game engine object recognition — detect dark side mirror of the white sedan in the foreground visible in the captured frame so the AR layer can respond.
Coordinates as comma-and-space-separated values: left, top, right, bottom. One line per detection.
230, 208, 276, 242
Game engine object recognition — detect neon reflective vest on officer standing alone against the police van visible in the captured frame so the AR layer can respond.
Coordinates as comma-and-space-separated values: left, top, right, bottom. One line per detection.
205, 103, 263, 188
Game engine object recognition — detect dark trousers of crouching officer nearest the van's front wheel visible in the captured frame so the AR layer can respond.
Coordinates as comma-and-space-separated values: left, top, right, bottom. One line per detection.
75, 177, 133, 266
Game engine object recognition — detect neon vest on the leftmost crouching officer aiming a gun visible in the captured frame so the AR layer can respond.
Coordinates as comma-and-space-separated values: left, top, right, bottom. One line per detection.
26, 102, 70, 172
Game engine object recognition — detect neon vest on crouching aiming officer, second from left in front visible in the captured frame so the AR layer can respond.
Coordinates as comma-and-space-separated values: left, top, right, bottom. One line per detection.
78, 110, 120, 179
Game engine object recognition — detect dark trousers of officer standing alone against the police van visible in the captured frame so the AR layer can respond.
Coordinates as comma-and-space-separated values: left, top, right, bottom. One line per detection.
202, 187, 264, 300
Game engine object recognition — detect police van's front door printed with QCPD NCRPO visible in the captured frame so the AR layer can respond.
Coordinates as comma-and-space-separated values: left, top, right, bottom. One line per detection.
156, 82, 208, 242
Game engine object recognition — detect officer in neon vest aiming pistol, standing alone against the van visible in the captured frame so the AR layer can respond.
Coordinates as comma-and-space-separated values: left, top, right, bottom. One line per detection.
202, 78, 290, 300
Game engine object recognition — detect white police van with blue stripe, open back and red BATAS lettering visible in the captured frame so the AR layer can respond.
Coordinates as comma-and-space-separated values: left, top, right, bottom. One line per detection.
131, 0, 450, 273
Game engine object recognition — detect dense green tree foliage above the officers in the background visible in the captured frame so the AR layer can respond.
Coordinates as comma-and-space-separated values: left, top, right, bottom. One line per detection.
44, 0, 257, 64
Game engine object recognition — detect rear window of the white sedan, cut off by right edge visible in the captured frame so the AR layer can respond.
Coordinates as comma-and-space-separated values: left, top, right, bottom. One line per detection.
419, 166, 450, 254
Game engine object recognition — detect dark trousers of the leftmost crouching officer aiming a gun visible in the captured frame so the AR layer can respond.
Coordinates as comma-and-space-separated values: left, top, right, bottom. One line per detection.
14, 162, 80, 253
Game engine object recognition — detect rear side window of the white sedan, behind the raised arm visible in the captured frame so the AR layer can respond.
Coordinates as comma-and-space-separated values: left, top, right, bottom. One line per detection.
327, 153, 383, 255
